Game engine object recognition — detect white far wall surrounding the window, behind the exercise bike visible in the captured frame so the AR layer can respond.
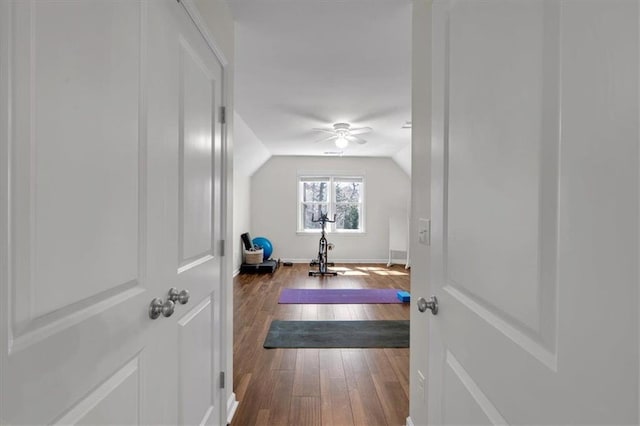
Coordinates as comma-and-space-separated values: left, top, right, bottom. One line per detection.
250, 156, 410, 263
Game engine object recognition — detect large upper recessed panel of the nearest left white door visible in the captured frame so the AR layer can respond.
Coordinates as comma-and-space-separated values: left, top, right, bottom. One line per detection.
21, 2, 142, 322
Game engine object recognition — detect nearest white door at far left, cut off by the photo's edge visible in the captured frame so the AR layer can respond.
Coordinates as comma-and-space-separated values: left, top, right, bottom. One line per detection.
0, 2, 153, 424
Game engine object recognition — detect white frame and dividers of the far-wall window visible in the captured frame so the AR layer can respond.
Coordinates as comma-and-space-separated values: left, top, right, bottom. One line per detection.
297, 173, 366, 235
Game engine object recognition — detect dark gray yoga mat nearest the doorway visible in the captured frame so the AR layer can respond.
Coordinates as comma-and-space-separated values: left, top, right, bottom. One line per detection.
264, 320, 409, 349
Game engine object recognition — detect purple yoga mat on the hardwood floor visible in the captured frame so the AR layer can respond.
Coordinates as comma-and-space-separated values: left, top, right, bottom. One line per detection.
278, 288, 402, 304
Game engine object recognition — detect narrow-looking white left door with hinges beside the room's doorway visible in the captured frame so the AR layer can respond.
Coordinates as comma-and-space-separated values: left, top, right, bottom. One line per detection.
148, 1, 223, 425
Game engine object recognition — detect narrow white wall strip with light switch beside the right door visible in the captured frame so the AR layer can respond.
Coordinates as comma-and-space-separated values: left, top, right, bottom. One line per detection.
409, 0, 431, 425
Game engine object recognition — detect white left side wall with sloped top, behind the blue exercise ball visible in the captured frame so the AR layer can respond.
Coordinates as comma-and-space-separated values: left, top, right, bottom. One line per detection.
232, 112, 271, 271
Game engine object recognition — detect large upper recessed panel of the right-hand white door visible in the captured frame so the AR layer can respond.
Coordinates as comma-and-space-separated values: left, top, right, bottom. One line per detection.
446, 2, 558, 331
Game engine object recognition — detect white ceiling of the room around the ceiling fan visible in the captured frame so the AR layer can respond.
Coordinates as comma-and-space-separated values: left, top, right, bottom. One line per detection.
228, 0, 411, 157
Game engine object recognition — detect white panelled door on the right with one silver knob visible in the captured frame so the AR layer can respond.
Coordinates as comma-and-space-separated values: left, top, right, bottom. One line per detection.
426, 0, 639, 424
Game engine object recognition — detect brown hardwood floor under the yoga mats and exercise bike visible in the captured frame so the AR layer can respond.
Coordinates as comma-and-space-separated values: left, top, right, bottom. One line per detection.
232, 264, 410, 426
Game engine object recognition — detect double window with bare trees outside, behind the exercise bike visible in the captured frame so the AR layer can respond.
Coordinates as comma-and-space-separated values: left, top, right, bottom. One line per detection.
298, 176, 364, 233
